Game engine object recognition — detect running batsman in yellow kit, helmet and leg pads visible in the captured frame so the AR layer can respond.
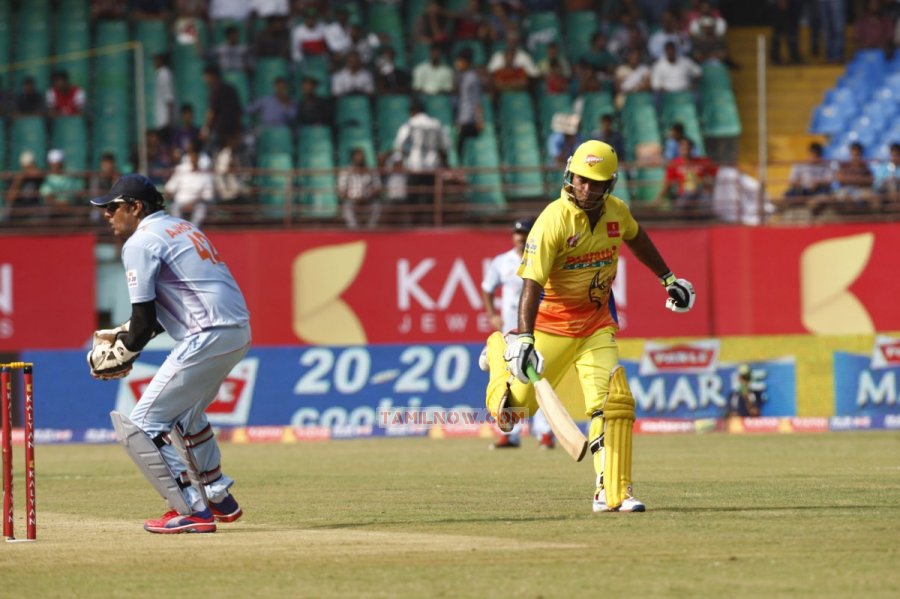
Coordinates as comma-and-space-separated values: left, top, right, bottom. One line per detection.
486, 140, 695, 512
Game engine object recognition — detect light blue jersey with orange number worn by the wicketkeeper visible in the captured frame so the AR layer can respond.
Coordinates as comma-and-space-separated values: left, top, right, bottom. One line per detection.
122, 211, 250, 341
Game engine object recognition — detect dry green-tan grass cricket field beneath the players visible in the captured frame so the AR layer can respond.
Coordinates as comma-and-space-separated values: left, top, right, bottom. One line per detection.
0, 432, 900, 599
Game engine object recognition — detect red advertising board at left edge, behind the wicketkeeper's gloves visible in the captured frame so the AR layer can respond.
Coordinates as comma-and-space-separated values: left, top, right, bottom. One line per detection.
0, 235, 97, 351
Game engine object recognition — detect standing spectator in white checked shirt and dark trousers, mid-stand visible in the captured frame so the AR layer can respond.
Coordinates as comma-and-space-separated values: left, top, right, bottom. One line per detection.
394, 98, 450, 224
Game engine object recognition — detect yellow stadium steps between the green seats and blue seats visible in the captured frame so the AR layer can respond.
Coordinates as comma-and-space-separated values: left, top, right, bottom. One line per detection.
728, 27, 849, 173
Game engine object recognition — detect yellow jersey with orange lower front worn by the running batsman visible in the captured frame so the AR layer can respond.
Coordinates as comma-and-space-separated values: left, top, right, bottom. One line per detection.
518, 193, 639, 337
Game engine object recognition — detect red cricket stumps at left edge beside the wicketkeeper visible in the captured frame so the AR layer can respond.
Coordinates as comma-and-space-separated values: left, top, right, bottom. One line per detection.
0, 362, 37, 542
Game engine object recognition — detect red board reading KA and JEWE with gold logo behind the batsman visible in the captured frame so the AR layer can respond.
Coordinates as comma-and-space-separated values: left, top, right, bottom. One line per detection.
212, 230, 710, 345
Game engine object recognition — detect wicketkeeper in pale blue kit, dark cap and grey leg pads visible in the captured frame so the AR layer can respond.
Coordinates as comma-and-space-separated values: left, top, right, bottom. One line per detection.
87, 175, 250, 533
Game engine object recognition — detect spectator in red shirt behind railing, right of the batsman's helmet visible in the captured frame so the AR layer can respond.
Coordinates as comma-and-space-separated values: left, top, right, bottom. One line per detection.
653, 138, 717, 218
